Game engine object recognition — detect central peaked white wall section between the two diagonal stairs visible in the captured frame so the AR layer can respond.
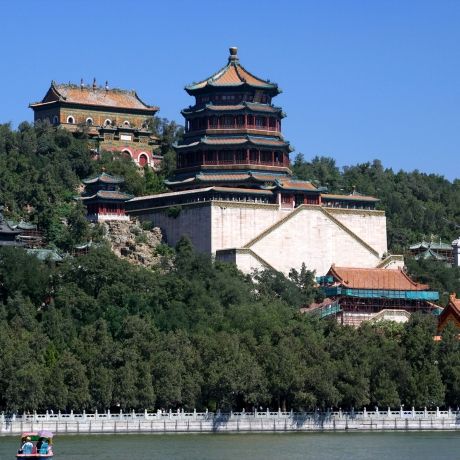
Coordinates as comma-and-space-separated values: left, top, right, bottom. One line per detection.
250, 206, 380, 275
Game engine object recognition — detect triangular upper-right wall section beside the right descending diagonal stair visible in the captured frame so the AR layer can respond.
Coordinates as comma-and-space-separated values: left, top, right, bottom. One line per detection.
326, 208, 387, 257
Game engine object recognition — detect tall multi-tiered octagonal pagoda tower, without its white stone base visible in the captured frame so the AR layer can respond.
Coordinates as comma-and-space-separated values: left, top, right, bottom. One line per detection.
167, 47, 320, 205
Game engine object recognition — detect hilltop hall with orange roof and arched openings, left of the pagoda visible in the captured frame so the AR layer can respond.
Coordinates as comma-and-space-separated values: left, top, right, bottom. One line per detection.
29, 80, 162, 168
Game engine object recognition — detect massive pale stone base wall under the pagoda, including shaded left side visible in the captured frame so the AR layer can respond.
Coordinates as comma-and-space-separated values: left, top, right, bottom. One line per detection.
135, 201, 387, 275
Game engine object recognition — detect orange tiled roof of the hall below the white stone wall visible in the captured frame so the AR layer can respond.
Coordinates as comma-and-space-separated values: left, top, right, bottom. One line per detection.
328, 265, 429, 291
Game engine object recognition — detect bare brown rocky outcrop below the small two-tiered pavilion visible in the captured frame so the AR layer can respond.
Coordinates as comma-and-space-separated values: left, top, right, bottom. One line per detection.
101, 221, 162, 267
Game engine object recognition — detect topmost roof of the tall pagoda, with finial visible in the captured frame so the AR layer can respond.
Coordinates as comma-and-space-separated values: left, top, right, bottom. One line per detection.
185, 47, 280, 94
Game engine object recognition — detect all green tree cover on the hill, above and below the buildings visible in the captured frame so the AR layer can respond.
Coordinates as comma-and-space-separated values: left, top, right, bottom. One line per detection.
0, 124, 460, 411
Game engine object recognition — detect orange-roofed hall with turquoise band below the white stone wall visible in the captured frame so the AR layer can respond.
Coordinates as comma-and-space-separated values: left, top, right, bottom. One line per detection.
308, 265, 442, 326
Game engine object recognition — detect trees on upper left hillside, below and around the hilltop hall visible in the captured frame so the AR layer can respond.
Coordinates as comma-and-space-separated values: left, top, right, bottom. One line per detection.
0, 119, 182, 250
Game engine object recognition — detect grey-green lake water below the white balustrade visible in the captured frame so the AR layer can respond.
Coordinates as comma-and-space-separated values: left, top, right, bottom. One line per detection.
0, 432, 460, 460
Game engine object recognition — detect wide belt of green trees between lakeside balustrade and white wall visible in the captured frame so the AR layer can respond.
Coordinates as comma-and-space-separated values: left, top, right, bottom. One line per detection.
0, 241, 460, 411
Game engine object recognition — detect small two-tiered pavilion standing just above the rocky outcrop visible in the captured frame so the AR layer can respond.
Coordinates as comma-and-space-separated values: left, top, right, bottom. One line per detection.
77, 172, 133, 222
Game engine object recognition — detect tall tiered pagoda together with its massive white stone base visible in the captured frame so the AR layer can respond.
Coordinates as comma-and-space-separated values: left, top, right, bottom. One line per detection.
126, 48, 402, 274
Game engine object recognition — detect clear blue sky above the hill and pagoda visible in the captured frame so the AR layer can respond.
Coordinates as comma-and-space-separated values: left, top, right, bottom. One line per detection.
0, 0, 460, 180
